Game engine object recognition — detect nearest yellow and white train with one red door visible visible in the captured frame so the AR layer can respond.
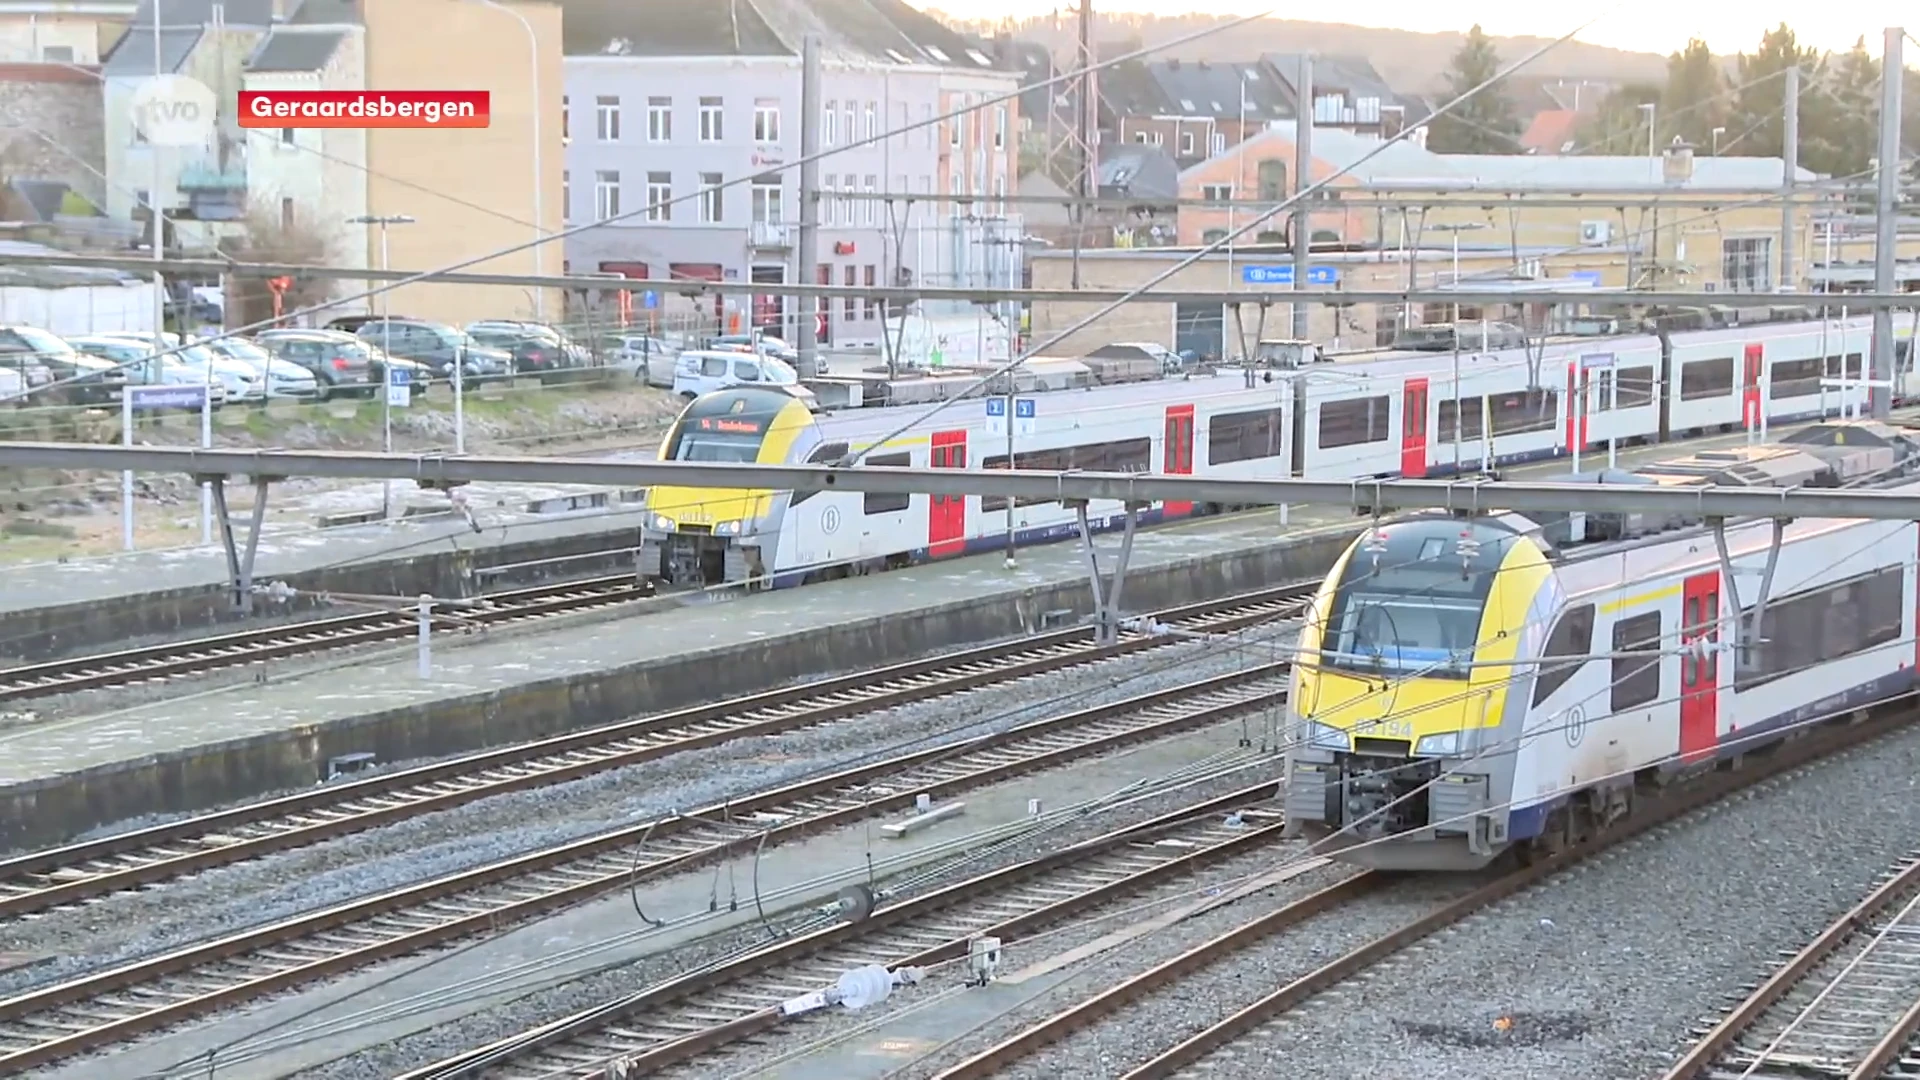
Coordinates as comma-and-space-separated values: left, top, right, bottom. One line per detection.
1286, 423, 1920, 871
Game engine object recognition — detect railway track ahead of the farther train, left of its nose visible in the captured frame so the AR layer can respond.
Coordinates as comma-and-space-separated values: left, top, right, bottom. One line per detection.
0, 575, 653, 701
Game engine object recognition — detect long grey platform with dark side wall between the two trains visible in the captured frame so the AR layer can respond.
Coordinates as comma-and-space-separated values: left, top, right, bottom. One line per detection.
0, 507, 1359, 847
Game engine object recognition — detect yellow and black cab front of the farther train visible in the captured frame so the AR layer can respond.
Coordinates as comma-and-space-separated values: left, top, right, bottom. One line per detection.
639, 386, 812, 588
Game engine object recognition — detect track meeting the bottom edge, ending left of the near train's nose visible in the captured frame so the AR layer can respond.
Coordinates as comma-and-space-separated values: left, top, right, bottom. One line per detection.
401, 782, 1305, 1080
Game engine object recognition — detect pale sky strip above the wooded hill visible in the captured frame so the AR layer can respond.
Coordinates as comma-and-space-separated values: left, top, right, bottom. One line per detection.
927, 0, 1920, 57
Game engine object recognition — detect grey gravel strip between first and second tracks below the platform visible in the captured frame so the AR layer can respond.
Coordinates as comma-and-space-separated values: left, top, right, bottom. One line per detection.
0, 630, 1286, 995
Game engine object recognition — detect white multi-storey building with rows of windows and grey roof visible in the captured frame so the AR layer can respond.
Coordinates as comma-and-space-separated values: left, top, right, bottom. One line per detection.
563, 0, 1021, 346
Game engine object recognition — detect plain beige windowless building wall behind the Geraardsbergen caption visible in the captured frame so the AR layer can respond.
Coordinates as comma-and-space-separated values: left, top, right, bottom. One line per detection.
365, 0, 566, 323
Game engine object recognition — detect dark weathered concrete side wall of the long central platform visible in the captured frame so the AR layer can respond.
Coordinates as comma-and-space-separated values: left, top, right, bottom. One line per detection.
0, 527, 1354, 847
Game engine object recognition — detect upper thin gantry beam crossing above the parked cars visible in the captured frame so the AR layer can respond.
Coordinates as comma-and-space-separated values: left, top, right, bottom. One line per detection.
22, 254, 1920, 313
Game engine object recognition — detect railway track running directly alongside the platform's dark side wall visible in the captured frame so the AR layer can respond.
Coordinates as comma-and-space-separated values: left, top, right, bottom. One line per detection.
0, 582, 1315, 919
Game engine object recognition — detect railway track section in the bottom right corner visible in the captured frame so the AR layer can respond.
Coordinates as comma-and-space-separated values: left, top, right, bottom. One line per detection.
1665, 851, 1920, 1080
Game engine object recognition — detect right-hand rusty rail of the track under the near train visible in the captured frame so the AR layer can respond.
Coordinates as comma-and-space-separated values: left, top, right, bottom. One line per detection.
1121, 696, 1920, 1080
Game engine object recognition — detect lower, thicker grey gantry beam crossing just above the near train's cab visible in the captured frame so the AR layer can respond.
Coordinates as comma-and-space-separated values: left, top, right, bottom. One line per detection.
11, 442, 1920, 521
